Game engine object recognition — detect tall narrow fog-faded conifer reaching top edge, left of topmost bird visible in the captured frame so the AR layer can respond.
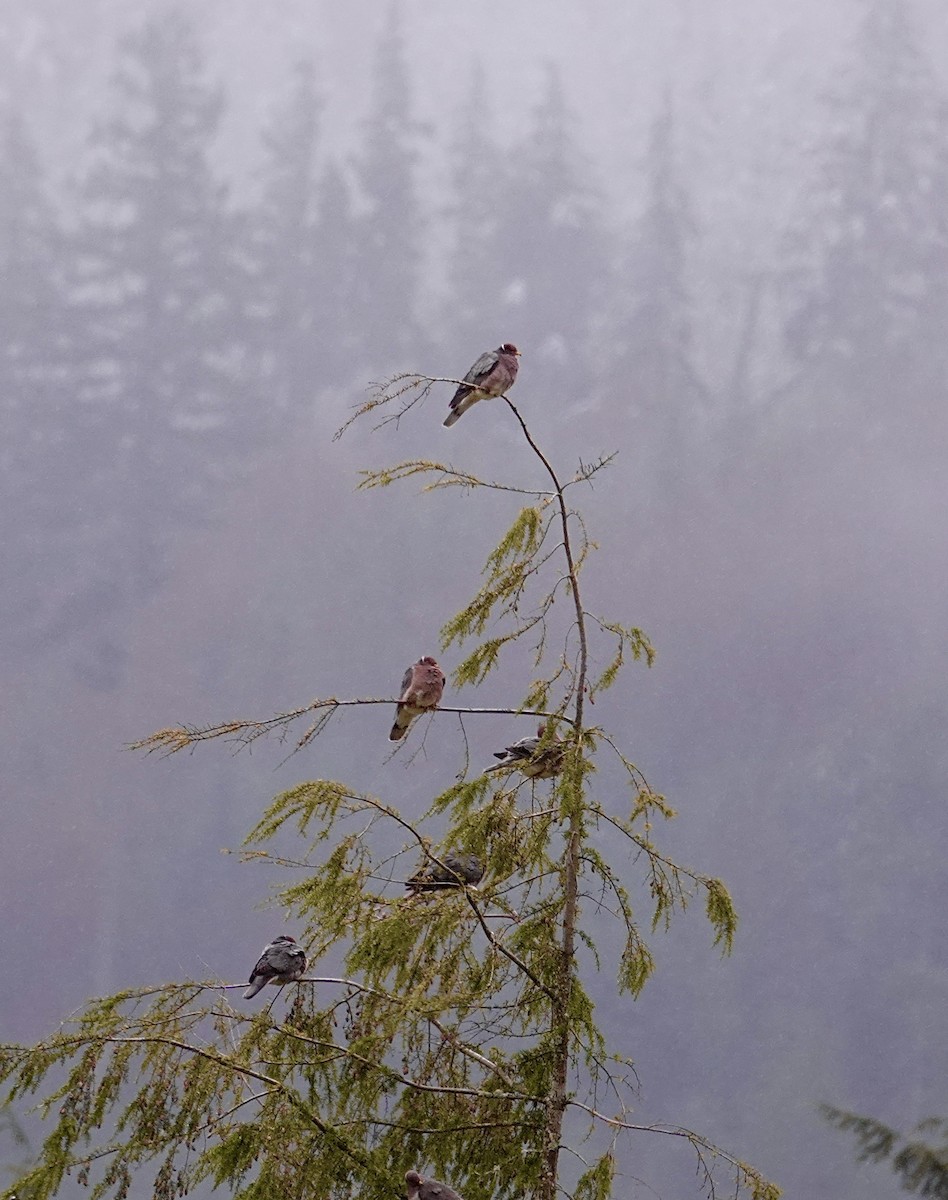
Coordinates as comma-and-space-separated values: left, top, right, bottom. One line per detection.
350, 5, 424, 367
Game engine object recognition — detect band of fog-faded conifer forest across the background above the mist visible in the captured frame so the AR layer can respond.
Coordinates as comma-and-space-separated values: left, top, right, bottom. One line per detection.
0, 2, 948, 688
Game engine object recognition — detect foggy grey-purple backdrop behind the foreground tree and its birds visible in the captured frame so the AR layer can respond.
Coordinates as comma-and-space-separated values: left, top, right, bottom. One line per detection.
0, 0, 948, 1200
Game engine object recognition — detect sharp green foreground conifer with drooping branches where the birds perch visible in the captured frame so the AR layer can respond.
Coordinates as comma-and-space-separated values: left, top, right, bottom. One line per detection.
0, 377, 779, 1200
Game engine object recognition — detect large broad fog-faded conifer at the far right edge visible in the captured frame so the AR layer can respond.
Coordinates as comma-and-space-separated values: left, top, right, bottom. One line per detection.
787, 0, 948, 446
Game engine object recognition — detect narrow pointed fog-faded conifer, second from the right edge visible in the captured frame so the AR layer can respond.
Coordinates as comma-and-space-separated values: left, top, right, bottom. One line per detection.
602, 97, 707, 468
